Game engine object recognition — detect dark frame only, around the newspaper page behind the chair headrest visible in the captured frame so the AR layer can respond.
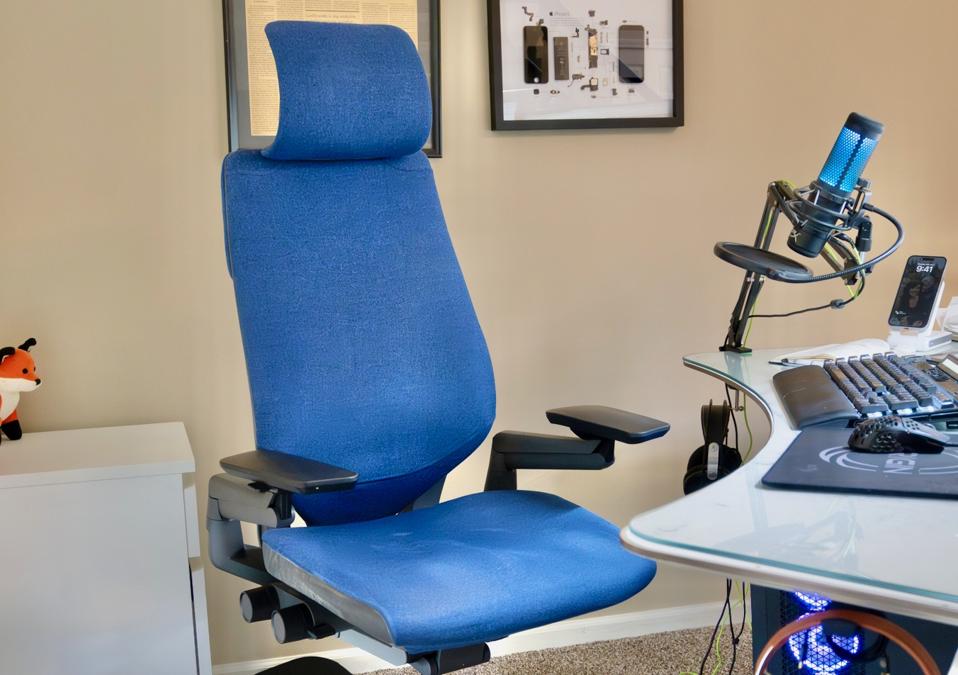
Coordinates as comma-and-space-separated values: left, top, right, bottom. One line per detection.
223, 0, 442, 158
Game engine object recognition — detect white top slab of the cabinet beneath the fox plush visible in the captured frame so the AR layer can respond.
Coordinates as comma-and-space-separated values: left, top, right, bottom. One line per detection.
0, 422, 196, 489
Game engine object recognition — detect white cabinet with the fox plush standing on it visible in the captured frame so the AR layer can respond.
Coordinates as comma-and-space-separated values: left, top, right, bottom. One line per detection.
0, 422, 211, 675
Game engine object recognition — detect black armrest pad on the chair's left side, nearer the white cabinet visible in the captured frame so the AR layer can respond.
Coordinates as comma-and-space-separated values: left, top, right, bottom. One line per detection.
220, 450, 359, 494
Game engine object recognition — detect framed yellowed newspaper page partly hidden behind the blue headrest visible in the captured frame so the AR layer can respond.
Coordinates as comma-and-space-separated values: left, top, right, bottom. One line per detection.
223, 0, 442, 157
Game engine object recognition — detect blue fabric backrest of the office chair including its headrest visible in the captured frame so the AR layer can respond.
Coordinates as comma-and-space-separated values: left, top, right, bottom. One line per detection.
222, 21, 495, 524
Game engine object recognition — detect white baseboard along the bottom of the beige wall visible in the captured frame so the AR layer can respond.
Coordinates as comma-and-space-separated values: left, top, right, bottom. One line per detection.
213, 602, 722, 675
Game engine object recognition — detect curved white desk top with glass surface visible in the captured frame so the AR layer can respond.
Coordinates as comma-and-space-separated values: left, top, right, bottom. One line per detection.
621, 350, 958, 625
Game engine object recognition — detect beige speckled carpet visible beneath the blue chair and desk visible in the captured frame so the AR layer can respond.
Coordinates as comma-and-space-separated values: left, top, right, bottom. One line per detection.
372, 626, 752, 675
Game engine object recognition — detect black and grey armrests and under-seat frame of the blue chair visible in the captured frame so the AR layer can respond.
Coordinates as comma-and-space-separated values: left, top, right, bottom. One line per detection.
206, 406, 669, 675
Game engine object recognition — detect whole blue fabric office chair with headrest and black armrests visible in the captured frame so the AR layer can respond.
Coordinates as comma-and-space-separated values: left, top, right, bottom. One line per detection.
207, 22, 668, 675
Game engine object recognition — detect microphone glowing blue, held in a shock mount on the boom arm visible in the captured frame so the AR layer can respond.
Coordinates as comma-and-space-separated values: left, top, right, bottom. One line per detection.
788, 113, 885, 258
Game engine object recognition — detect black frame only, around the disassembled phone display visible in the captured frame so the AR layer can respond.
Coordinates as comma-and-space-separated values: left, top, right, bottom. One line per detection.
486, 0, 685, 131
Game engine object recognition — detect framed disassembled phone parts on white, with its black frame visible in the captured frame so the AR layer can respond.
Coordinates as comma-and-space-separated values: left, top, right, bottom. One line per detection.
488, 0, 684, 130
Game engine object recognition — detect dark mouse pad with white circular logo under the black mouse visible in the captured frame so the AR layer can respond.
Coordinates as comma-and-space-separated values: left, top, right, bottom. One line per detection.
762, 427, 958, 499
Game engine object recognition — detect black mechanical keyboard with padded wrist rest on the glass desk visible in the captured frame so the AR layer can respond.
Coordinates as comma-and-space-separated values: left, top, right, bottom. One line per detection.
773, 353, 958, 429
